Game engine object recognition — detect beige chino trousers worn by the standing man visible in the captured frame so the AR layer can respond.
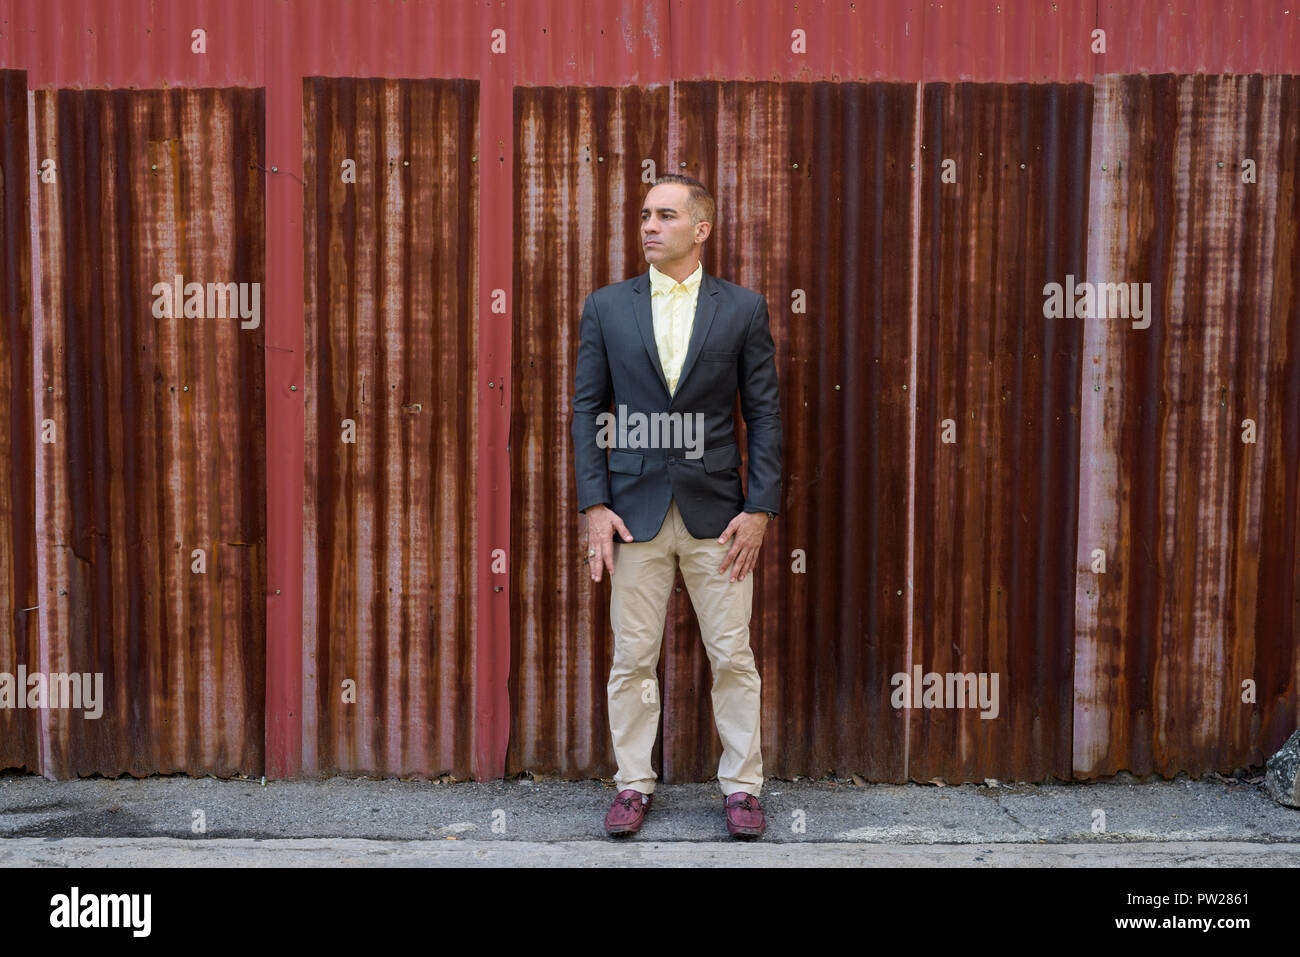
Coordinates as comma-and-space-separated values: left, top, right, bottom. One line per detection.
607, 499, 763, 797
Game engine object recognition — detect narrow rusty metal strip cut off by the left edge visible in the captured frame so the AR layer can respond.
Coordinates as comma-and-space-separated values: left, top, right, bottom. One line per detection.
0, 70, 40, 771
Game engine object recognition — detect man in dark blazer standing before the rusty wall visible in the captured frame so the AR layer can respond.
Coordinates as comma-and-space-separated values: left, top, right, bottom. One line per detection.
572, 174, 781, 837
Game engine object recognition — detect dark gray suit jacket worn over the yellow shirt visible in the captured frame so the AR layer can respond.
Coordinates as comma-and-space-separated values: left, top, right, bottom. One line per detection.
572, 270, 781, 542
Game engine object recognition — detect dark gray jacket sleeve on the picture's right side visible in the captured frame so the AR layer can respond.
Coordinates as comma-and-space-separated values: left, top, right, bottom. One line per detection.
740, 296, 783, 512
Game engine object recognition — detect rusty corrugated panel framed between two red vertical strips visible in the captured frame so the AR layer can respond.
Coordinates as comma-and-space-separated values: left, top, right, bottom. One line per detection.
303, 77, 478, 778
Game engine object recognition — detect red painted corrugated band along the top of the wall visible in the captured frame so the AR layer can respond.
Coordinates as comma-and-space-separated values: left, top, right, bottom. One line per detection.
0, 0, 1300, 88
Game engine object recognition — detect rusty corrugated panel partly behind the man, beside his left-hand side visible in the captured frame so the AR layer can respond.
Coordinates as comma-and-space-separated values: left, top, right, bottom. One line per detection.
506, 87, 671, 778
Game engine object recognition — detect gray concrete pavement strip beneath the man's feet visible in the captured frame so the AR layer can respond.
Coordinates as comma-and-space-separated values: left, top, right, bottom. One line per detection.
0, 774, 1300, 867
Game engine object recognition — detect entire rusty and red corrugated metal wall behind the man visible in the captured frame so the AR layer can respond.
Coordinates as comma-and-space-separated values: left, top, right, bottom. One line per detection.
0, 0, 1300, 780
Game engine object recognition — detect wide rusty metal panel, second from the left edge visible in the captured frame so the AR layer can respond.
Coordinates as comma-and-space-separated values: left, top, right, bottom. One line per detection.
33, 90, 267, 778
